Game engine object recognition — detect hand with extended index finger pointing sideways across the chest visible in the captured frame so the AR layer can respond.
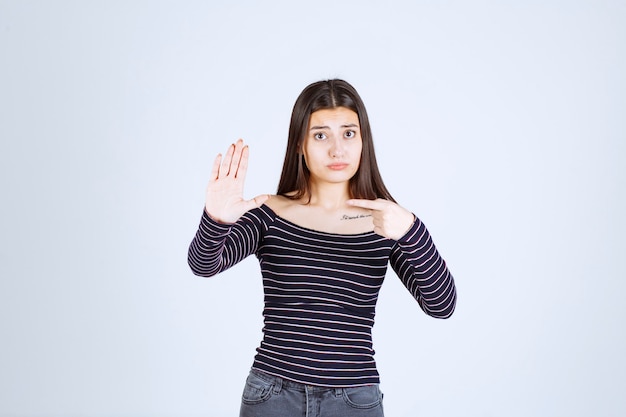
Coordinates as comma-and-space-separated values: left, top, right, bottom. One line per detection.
347, 198, 415, 240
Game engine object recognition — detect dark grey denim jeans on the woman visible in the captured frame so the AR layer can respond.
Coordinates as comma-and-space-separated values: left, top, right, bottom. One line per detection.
239, 369, 384, 417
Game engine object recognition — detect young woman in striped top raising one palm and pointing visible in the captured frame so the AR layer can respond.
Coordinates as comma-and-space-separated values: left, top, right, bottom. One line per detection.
189, 80, 456, 417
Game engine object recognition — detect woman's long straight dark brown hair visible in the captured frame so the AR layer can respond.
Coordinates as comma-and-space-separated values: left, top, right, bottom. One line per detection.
276, 79, 395, 202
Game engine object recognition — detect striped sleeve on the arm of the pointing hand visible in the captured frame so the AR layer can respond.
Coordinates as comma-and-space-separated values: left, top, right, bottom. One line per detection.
389, 217, 456, 319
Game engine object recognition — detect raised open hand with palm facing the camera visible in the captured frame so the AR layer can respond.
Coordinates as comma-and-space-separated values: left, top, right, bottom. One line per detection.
205, 139, 269, 223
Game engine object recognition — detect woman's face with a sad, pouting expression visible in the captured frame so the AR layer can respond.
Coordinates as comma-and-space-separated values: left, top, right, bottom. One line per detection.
302, 107, 363, 183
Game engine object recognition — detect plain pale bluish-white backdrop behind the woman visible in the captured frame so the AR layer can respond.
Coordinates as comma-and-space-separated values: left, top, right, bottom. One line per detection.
0, 0, 626, 417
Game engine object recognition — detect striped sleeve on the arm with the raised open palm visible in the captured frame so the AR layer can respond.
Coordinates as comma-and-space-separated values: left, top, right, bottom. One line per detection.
187, 208, 267, 278
